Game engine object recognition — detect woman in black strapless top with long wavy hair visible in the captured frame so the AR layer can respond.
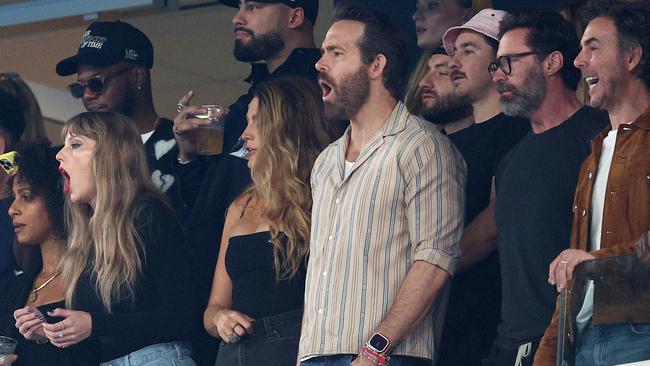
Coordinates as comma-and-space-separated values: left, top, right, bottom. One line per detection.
203, 77, 333, 366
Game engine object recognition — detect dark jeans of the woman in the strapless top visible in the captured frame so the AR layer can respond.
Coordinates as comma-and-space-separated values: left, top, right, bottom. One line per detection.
215, 310, 302, 366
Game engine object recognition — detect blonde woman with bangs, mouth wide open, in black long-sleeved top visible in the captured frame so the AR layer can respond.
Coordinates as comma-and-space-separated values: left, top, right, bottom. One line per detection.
43, 112, 195, 366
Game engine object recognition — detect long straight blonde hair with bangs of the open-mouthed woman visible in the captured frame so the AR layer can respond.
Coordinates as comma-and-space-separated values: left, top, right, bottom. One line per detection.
62, 112, 164, 312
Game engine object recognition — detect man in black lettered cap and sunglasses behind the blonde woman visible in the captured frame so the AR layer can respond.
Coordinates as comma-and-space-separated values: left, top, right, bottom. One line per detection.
56, 21, 200, 218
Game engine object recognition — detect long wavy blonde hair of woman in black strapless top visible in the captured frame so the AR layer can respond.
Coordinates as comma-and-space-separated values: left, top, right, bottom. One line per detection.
245, 77, 335, 279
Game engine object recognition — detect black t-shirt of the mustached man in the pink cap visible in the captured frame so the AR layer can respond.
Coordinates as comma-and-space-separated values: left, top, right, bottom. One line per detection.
437, 113, 530, 366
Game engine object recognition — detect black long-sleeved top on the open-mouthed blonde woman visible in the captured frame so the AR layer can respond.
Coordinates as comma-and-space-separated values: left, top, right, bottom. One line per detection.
74, 196, 195, 362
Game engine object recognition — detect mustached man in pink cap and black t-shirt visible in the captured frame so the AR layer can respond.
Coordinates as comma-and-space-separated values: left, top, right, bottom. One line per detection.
425, 9, 530, 366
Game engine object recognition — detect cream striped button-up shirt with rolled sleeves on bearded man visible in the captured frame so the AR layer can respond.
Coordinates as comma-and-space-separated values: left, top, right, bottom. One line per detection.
299, 103, 466, 360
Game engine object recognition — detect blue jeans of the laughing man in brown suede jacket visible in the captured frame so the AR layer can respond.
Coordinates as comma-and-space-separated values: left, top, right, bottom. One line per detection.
575, 324, 650, 366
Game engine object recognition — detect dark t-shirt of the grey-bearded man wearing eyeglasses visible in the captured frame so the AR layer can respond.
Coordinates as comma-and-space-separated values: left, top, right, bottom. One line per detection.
495, 107, 609, 349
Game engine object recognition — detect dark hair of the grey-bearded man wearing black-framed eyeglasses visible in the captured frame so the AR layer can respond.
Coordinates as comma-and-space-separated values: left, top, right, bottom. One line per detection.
499, 9, 580, 90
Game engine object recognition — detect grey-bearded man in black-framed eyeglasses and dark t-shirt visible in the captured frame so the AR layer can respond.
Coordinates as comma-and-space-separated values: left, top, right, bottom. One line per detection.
476, 10, 608, 366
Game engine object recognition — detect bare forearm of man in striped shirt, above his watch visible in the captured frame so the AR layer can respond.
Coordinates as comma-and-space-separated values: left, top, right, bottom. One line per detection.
375, 261, 451, 346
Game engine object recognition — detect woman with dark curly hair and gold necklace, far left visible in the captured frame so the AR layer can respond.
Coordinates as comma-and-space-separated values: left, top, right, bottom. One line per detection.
0, 144, 96, 366
